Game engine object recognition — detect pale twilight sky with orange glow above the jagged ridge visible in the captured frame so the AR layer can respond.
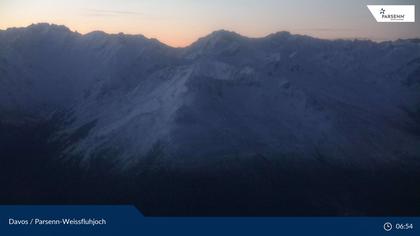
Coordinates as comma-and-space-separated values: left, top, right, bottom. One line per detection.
0, 0, 420, 46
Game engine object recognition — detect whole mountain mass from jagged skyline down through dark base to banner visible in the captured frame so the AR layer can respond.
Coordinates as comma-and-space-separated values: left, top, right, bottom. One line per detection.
0, 24, 420, 216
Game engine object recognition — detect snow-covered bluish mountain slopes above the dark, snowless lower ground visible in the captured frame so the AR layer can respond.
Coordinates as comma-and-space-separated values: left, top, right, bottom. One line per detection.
0, 24, 420, 166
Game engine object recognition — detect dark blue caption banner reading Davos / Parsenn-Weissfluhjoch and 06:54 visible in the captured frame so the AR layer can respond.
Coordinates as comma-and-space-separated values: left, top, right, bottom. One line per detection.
0, 205, 420, 236
